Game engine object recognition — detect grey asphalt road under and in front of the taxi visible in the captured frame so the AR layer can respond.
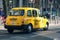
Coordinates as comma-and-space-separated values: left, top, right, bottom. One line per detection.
0, 26, 60, 40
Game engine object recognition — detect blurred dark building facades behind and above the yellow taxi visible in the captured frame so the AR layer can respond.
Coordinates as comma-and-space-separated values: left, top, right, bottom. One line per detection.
0, 0, 60, 16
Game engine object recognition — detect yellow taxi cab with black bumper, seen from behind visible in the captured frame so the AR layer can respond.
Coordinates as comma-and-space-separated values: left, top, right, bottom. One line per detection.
4, 7, 49, 33
